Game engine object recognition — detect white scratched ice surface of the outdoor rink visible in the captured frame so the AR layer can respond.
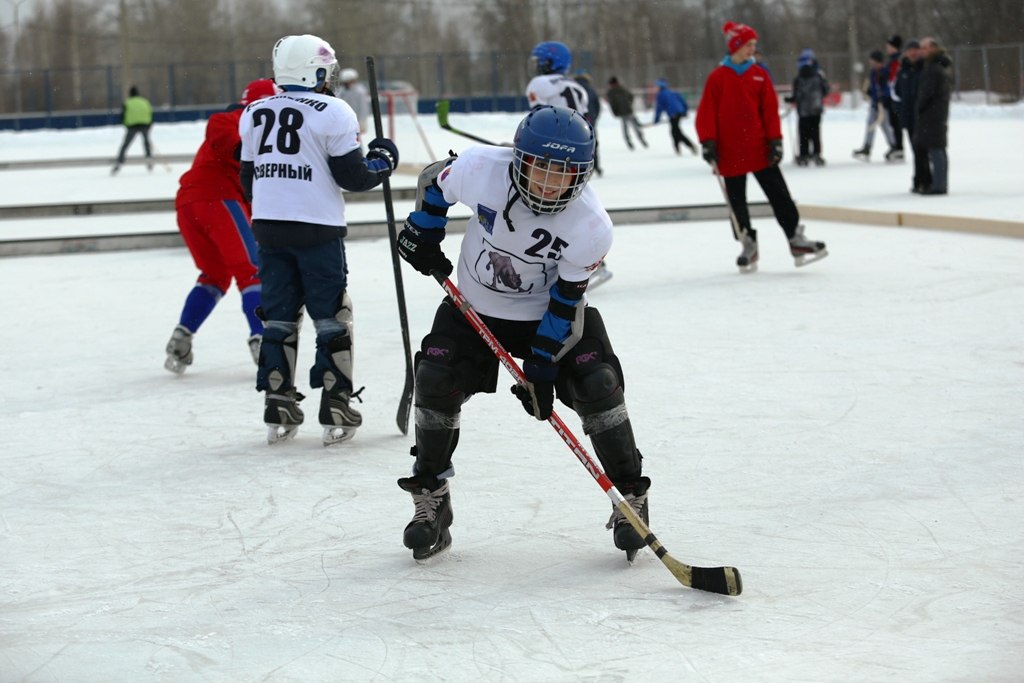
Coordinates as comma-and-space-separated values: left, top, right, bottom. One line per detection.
0, 98, 1024, 683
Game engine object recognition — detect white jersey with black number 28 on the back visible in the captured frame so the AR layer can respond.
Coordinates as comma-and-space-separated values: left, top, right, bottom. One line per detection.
239, 91, 360, 226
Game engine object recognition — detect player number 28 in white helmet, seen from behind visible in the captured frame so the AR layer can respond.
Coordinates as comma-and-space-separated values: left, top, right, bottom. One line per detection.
239, 34, 398, 445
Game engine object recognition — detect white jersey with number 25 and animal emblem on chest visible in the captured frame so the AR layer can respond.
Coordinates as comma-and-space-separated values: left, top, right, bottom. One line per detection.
437, 146, 611, 321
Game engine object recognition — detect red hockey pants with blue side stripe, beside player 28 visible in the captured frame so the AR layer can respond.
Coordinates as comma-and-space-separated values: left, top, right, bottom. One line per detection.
177, 200, 259, 292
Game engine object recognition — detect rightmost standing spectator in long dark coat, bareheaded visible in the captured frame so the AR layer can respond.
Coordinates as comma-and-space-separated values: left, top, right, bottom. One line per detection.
913, 38, 953, 195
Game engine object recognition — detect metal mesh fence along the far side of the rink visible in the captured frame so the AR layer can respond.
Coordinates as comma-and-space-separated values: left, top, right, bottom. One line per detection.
0, 43, 1024, 128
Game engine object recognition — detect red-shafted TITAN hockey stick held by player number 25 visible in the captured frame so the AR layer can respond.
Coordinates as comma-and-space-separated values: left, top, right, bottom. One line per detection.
434, 271, 743, 595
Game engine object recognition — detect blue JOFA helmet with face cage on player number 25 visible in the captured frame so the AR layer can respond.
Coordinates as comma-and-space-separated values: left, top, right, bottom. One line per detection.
512, 105, 595, 214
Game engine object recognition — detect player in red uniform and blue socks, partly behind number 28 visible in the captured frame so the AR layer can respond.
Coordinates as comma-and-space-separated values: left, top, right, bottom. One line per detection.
164, 79, 279, 374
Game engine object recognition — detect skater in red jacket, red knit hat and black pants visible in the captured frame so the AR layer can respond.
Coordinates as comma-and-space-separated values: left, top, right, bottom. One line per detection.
696, 22, 827, 272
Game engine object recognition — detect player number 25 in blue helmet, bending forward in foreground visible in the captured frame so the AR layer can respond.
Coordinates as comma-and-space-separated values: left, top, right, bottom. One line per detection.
398, 105, 650, 559
